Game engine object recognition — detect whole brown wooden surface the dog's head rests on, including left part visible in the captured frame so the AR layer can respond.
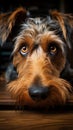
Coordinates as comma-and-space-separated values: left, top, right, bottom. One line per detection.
0, 75, 73, 130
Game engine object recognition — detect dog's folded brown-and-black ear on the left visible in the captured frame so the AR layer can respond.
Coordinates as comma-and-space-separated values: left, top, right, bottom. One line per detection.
0, 7, 26, 43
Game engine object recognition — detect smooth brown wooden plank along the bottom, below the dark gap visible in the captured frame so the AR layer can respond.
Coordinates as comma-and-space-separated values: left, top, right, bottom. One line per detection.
0, 111, 73, 130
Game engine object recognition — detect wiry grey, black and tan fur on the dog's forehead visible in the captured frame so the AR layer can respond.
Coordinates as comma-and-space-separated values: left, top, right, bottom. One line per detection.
18, 16, 63, 37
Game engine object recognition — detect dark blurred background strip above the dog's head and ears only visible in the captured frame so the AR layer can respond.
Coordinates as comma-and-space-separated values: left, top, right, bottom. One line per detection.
0, 0, 73, 13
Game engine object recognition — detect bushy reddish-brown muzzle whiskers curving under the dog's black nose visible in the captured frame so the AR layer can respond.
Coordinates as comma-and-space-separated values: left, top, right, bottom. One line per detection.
8, 79, 71, 109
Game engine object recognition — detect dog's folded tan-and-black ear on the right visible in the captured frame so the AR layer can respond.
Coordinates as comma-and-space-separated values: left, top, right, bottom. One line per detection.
50, 11, 73, 48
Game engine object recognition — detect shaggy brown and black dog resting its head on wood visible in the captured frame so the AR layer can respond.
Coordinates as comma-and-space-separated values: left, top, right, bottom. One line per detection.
0, 7, 73, 108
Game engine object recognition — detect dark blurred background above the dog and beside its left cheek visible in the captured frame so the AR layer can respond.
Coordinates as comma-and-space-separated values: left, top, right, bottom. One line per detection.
0, 0, 73, 74
